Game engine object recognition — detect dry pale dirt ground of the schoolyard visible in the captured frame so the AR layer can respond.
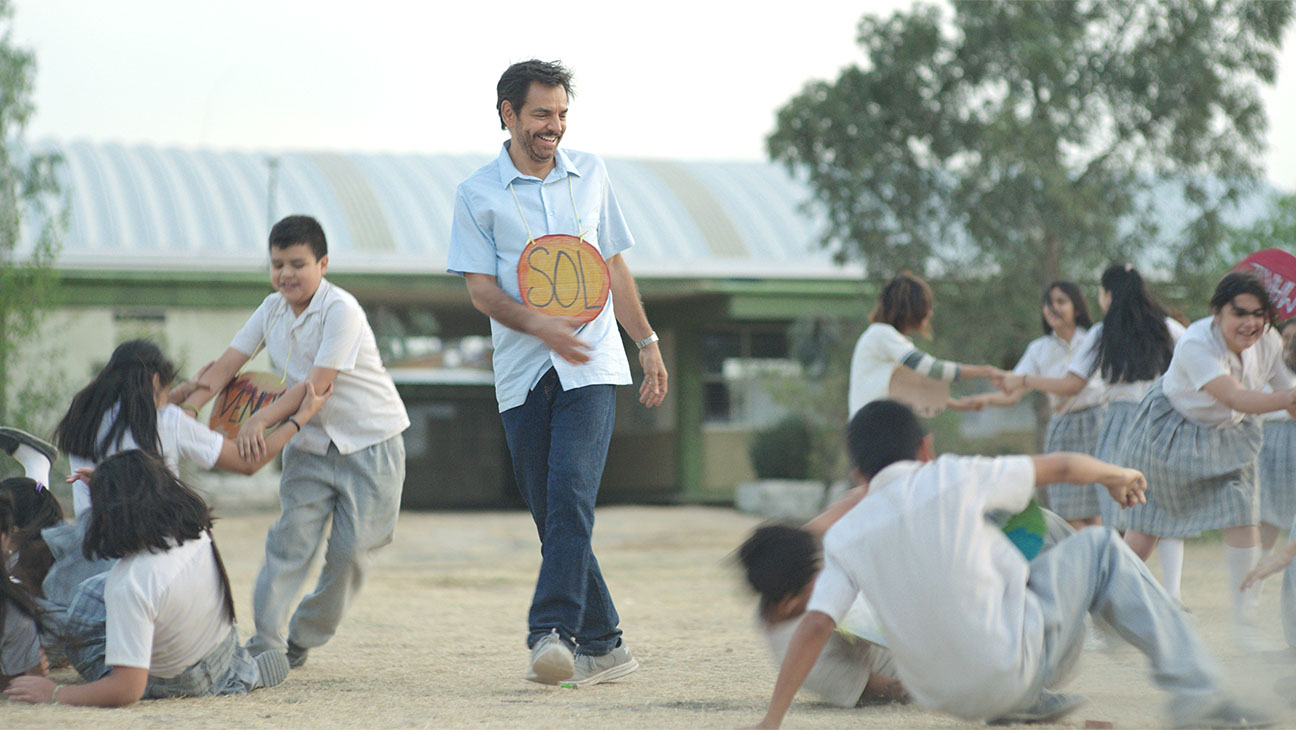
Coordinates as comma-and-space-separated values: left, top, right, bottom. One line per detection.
0, 507, 1296, 730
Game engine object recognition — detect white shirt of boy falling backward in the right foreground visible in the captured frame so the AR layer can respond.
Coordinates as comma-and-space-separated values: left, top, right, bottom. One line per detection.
807, 455, 1043, 720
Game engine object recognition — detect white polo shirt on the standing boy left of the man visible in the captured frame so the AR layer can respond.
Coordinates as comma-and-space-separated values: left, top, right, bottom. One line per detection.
229, 279, 410, 455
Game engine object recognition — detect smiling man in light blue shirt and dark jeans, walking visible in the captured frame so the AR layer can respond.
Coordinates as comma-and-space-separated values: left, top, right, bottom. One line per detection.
447, 60, 666, 686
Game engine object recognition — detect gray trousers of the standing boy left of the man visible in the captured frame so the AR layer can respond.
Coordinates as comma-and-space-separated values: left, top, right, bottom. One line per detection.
248, 434, 404, 655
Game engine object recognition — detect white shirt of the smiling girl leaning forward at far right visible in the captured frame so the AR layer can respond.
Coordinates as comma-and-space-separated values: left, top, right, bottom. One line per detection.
1161, 316, 1296, 427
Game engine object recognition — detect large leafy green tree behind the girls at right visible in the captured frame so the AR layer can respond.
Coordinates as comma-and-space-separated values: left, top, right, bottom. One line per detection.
769, 0, 1292, 364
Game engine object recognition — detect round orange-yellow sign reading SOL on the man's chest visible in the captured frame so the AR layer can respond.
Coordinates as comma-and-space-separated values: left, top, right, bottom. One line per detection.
517, 235, 612, 324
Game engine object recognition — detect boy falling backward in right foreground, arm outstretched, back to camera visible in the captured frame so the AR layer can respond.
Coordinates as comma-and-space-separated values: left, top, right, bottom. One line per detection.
759, 401, 1271, 727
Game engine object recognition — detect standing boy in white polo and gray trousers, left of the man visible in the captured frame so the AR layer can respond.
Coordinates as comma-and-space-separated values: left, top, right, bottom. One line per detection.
188, 215, 410, 668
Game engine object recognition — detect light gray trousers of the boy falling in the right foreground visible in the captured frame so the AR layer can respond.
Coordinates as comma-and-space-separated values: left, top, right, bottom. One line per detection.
1024, 528, 1223, 720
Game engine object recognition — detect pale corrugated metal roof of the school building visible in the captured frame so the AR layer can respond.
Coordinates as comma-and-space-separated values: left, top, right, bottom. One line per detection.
27, 143, 859, 279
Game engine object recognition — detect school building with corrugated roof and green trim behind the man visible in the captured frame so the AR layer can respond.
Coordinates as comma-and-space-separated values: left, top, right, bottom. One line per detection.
22, 143, 871, 507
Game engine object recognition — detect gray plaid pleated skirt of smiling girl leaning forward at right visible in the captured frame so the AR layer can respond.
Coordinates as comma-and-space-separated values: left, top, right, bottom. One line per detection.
1117, 380, 1264, 537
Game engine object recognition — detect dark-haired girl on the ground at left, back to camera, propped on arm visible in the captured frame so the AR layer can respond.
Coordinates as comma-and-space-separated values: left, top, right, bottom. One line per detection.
5, 449, 288, 707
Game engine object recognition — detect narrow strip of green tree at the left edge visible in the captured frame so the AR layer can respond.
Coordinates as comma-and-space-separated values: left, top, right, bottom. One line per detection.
0, 0, 65, 429
